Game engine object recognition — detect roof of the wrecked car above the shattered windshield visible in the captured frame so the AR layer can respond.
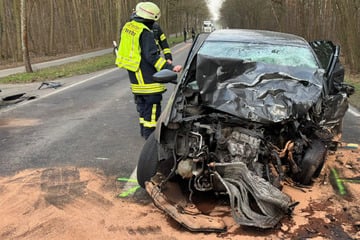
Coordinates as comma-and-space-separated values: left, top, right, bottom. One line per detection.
206, 29, 309, 47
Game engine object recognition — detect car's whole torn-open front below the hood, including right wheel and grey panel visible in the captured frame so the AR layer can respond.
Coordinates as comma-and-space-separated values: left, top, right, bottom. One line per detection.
150, 77, 333, 228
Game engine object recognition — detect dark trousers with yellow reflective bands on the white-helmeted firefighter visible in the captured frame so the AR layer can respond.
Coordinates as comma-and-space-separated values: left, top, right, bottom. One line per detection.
135, 94, 162, 139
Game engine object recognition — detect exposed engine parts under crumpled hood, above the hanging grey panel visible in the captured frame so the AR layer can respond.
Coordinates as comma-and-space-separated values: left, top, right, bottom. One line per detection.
166, 114, 326, 191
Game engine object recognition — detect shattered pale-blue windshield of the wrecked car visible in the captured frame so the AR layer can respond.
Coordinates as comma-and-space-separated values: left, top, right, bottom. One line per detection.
199, 42, 319, 68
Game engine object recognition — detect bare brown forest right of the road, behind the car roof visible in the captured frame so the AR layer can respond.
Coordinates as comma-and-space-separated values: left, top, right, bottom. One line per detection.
220, 0, 360, 73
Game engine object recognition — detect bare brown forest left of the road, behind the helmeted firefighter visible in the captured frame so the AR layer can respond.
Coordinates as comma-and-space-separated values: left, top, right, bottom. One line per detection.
0, 0, 209, 68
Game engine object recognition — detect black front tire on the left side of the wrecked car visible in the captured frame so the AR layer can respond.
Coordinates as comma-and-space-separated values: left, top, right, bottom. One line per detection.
137, 133, 158, 188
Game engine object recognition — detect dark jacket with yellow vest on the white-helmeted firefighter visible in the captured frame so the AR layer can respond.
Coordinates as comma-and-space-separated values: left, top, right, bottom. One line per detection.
115, 20, 173, 94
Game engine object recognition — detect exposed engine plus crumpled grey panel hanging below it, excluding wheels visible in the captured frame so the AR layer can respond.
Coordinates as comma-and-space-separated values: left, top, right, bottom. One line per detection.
158, 113, 318, 228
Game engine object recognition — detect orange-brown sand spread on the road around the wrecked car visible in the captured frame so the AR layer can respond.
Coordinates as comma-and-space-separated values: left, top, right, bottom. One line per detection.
0, 143, 360, 240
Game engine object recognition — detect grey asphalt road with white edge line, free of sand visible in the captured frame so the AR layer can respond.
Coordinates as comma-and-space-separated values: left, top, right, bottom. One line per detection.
0, 43, 360, 177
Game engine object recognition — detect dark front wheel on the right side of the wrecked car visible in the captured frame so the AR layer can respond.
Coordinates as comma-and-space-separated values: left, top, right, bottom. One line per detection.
295, 140, 326, 185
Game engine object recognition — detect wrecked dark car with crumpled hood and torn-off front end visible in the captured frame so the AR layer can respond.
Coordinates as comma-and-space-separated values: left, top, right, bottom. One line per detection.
137, 29, 353, 231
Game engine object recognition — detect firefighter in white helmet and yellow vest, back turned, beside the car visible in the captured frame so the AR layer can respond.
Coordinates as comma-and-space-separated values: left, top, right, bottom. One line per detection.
115, 2, 182, 139
